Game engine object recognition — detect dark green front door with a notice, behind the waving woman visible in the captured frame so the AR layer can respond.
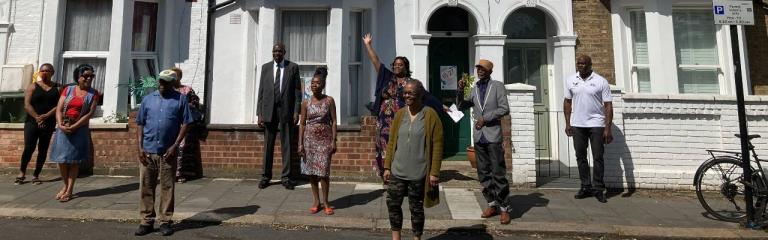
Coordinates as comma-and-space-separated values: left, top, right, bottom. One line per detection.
429, 37, 472, 160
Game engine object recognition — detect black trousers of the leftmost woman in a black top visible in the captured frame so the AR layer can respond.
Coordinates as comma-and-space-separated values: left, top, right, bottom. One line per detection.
19, 122, 53, 177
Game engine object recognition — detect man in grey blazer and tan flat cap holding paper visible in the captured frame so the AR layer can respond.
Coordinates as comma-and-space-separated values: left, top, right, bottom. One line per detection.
456, 59, 511, 224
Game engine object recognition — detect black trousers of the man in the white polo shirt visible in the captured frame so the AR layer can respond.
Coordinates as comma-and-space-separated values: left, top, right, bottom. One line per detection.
573, 127, 605, 191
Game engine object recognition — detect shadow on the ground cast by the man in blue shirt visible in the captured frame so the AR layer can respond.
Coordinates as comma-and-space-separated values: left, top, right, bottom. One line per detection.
173, 205, 261, 231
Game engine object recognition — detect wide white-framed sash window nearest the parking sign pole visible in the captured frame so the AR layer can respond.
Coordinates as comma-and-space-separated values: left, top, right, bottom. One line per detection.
672, 9, 720, 94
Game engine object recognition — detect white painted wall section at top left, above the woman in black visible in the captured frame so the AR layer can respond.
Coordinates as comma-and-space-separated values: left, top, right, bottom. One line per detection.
6, 0, 43, 65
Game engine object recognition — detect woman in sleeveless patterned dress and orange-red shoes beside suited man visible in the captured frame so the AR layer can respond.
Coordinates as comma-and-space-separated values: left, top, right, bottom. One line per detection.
299, 67, 336, 215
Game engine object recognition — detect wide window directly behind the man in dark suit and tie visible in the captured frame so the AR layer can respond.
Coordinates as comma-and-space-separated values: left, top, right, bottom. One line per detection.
280, 10, 328, 98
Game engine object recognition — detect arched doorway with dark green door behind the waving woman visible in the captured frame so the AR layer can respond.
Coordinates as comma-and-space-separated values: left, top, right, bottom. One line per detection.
427, 7, 477, 161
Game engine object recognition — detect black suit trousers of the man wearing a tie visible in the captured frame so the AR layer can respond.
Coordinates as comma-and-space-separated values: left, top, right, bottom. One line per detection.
261, 107, 294, 181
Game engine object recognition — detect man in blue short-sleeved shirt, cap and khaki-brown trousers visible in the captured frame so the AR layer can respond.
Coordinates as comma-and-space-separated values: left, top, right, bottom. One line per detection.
135, 70, 194, 236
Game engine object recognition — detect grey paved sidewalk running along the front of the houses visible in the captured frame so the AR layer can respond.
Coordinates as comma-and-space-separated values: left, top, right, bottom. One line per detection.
0, 175, 768, 239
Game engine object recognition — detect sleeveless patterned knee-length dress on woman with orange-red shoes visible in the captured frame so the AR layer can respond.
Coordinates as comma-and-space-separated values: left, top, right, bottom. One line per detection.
301, 97, 333, 177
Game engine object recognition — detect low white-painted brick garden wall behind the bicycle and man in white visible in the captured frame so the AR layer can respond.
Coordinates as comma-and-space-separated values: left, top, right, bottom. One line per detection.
507, 88, 768, 190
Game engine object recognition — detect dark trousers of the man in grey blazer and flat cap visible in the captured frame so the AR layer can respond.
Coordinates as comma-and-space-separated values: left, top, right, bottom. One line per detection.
475, 143, 509, 209
